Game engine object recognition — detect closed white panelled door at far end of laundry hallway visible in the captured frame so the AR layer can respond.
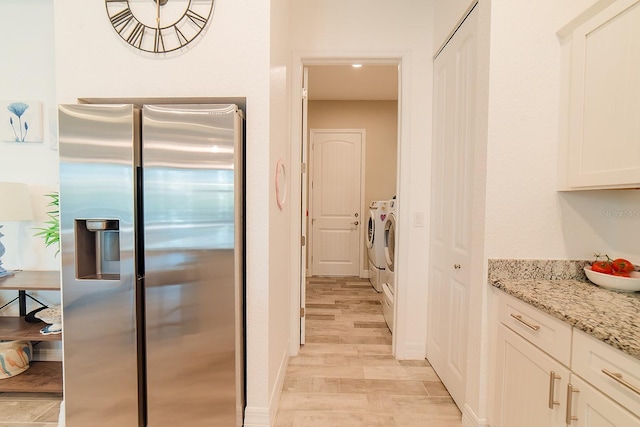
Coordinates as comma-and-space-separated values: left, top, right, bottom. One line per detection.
310, 129, 364, 276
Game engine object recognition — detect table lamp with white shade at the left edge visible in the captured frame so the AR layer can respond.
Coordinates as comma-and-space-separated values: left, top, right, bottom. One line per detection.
0, 182, 33, 277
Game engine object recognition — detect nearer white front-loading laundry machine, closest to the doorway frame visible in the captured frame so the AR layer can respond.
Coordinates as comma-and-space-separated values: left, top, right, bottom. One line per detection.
382, 199, 398, 333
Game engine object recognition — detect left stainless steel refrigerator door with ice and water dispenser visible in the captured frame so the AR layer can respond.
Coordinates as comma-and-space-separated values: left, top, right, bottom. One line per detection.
59, 105, 139, 427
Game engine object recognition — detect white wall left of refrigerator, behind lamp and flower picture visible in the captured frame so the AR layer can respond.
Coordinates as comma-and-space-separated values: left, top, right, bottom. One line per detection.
0, 0, 60, 270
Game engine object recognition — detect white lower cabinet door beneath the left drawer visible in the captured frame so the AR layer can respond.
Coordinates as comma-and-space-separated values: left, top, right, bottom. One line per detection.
491, 324, 570, 427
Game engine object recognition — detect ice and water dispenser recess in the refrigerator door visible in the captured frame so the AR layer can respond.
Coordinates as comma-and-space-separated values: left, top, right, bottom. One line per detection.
75, 219, 120, 280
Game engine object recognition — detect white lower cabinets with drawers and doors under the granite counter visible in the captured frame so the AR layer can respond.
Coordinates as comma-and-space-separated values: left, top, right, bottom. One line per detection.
491, 292, 640, 427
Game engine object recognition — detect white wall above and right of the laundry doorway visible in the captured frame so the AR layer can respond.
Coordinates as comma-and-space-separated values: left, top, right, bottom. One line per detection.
291, 0, 433, 358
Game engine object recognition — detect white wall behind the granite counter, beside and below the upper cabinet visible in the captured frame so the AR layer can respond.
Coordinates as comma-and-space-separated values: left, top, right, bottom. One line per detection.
486, 0, 640, 262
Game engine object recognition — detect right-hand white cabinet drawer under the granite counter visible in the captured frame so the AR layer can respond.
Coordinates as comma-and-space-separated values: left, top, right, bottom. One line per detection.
571, 330, 640, 414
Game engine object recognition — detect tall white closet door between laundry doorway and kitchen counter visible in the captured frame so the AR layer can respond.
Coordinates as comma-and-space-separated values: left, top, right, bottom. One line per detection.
427, 5, 477, 407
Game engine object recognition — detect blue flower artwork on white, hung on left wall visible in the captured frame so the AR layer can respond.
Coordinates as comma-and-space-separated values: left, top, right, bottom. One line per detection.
0, 101, 43, 143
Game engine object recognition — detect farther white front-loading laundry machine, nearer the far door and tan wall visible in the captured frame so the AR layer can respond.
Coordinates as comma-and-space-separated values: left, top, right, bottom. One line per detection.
367, 200, 388, 292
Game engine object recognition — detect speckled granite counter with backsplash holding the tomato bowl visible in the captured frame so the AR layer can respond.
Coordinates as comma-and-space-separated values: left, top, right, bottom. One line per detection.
489, 259, 640, 360
